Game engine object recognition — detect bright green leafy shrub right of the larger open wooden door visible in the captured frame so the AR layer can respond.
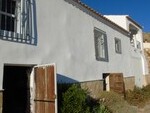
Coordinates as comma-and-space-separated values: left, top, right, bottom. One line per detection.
61, 84, 90, 113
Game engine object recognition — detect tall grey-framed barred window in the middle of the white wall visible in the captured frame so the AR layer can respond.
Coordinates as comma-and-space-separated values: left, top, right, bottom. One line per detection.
94, 28, 108, 61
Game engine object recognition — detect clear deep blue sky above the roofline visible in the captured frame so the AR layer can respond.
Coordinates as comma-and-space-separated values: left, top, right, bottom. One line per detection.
81, 0, 150, 32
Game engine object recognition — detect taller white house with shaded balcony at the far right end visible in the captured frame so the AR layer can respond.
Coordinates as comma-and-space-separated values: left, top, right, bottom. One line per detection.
105, 15, 148, 86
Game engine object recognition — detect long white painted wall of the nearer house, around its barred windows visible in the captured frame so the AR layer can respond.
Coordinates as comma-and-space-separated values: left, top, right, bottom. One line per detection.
0, 0, 145, 89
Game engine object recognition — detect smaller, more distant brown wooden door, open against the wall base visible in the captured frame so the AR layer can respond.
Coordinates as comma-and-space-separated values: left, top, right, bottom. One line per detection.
109, 73, 125, 94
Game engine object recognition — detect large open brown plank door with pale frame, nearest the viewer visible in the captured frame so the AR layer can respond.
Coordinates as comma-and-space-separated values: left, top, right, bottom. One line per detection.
34, 65, 56, 113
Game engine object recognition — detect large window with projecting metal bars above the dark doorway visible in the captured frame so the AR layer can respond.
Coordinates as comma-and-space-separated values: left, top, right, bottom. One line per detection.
0, 0, 37, 45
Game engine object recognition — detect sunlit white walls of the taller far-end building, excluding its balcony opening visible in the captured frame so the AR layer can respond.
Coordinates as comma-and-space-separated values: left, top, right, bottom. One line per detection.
105, 15, 148, 86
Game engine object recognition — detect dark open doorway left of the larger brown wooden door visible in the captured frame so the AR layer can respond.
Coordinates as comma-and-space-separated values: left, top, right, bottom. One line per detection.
2, 66, 32, 113
